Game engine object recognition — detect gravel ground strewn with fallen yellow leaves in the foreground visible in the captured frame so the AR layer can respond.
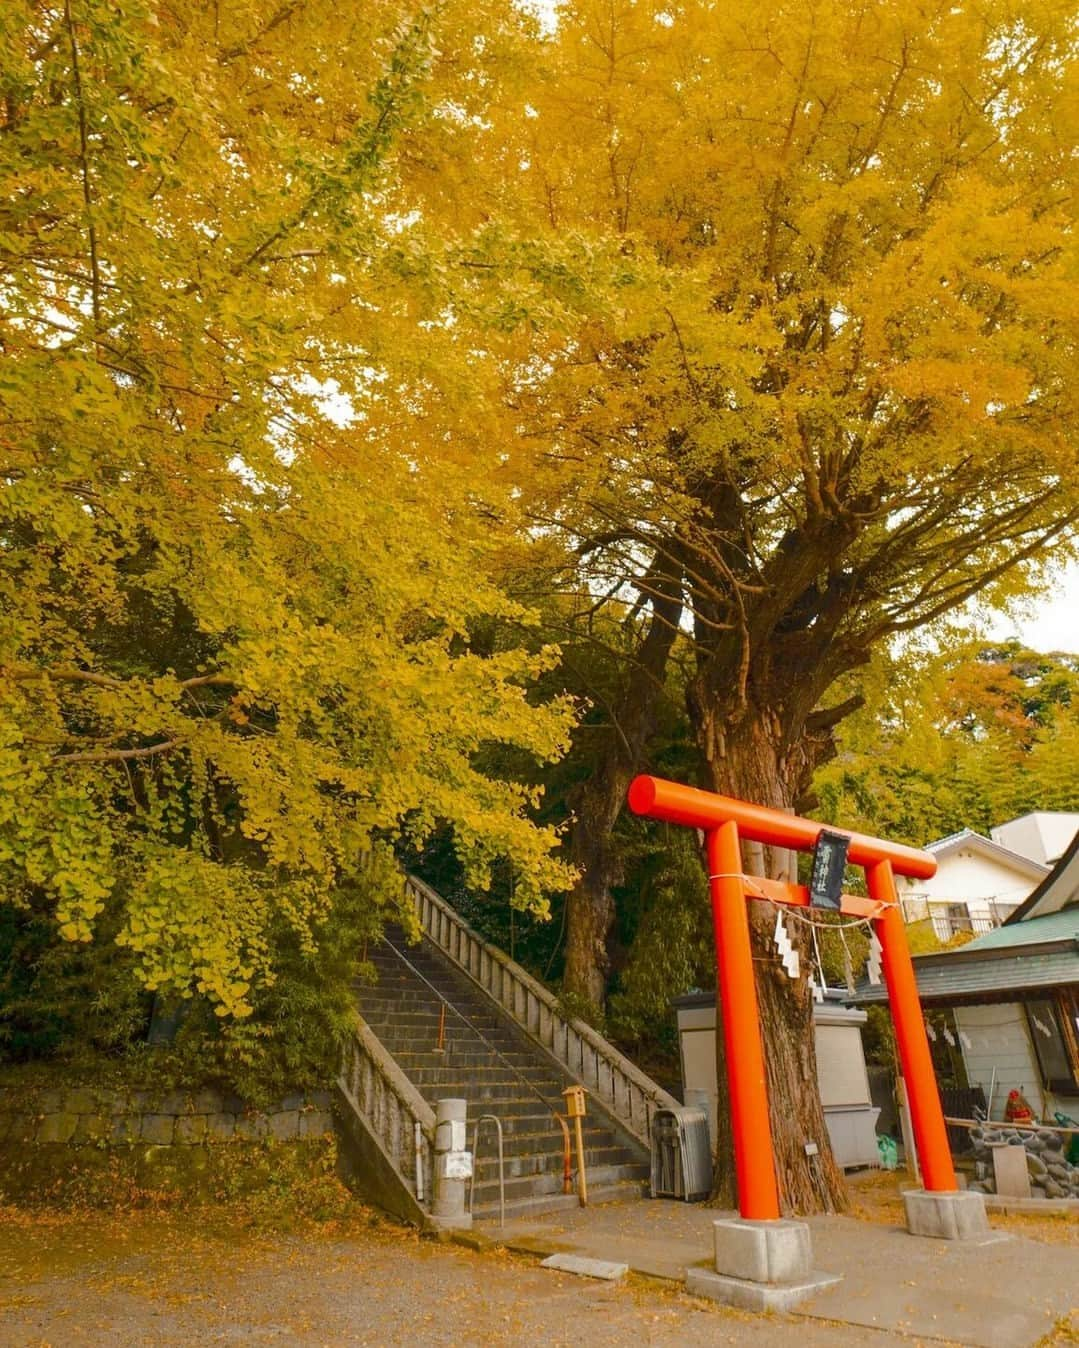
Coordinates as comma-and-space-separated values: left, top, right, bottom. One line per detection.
0, 1211, 971, 1348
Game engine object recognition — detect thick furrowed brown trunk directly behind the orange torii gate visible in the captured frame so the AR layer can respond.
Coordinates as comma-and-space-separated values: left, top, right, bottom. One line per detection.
693, 692, 847, 1216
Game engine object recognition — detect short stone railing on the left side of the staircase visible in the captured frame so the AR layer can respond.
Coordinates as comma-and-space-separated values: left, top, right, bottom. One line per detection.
337, 1020, 434, 1209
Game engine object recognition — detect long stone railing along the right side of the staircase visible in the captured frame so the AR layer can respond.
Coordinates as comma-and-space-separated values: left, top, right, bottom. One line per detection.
406, 876, 678, 1148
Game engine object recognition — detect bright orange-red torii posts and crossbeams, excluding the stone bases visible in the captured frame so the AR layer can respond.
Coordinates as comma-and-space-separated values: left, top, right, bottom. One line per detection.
629, 776, 956, 1221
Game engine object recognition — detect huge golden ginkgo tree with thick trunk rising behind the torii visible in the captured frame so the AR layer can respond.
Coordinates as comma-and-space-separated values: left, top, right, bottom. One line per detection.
506, 0, 1079, 1211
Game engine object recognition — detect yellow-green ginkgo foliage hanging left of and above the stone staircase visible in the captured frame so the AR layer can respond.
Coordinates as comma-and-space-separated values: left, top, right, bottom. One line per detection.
0, 0, 571, 1051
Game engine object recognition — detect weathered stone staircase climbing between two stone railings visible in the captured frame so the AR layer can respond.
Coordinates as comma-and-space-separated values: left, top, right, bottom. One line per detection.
357, 930, 649, 1221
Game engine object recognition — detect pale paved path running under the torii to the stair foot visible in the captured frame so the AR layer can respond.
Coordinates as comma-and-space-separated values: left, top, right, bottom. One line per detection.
491, 1200, 1079, 1348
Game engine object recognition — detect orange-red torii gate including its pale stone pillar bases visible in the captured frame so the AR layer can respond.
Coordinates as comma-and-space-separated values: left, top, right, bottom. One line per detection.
629, 776, 989, 1309
